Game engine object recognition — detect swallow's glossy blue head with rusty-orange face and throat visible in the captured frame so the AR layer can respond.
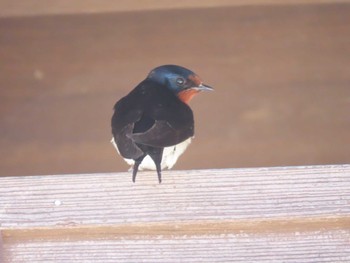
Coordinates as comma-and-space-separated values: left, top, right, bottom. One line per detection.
147, 65, 213, 103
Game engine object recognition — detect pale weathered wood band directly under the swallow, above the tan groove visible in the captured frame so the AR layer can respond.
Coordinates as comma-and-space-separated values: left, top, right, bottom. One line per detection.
0, 165, 350, 229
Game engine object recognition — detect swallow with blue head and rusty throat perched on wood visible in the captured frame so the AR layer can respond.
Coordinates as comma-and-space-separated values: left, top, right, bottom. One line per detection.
111, 65, 214, 183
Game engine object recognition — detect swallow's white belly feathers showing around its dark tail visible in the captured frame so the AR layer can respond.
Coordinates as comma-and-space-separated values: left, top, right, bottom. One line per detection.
111, 137, 192, 170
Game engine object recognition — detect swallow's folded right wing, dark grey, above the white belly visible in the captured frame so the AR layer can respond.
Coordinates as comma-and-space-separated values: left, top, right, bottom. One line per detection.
128, 120, 194, 147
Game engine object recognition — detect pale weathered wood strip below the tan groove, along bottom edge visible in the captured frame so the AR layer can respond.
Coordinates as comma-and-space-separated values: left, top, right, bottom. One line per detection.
5, 230, 350, 263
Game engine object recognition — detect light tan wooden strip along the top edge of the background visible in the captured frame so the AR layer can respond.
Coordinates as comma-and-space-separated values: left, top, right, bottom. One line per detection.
0, 0, 349, 17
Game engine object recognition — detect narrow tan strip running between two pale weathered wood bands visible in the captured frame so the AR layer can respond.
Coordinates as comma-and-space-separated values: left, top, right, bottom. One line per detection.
2, 215, 350, 242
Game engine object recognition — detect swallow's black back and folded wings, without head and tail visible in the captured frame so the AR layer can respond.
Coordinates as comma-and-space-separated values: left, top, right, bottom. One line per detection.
112, 83, 194, 155
